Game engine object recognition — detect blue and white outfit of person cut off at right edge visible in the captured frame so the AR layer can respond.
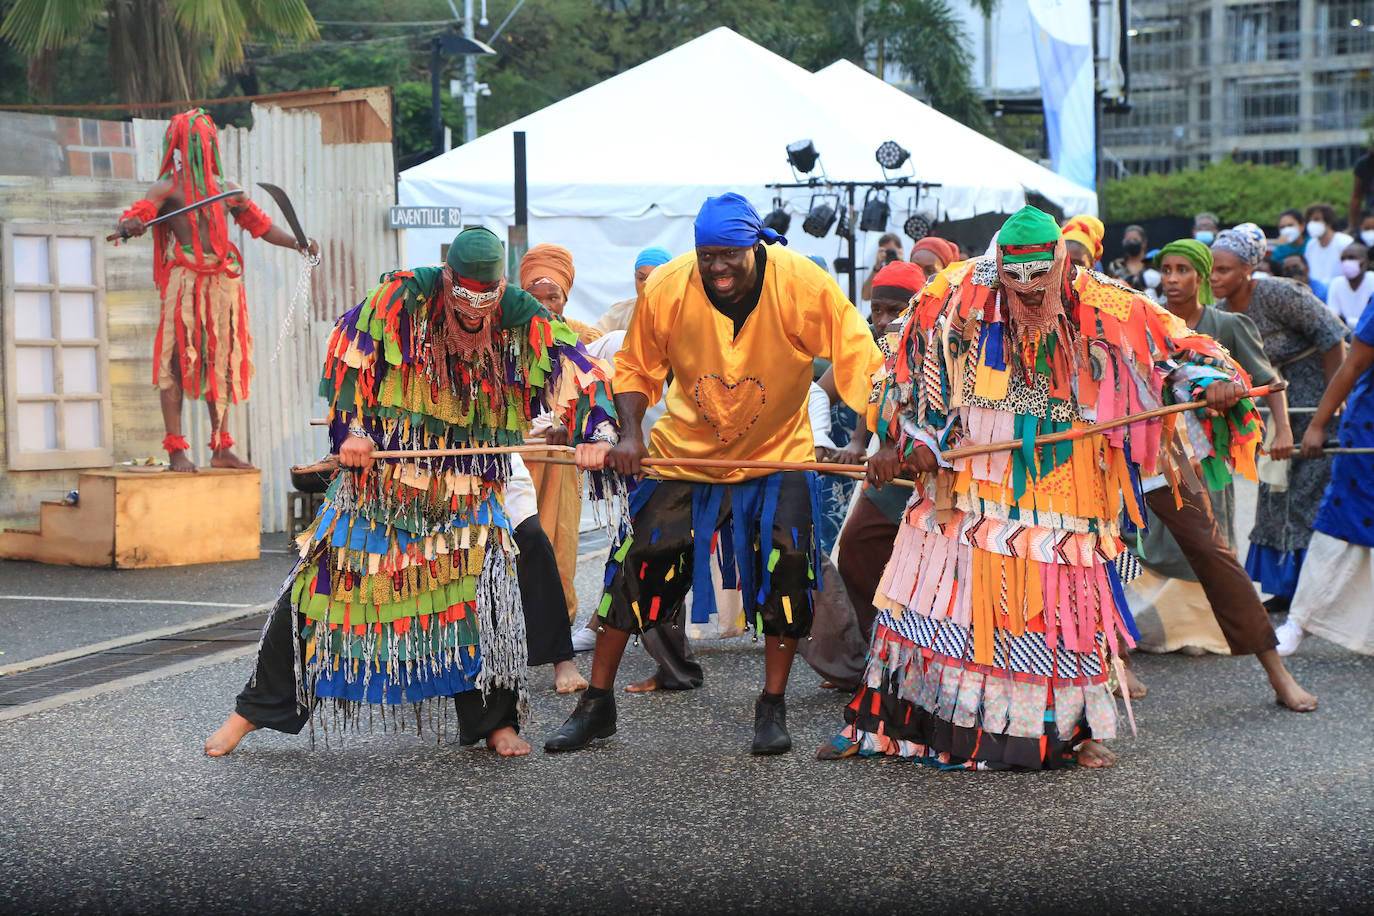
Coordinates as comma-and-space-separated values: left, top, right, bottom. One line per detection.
1289, 305, 1374, 655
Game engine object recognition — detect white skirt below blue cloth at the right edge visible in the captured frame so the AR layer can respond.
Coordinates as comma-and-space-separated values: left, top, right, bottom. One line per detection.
1289, 531, 1374, 655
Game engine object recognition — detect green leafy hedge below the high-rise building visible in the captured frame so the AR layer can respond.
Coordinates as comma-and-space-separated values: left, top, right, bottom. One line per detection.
1098, 159, 1351, 225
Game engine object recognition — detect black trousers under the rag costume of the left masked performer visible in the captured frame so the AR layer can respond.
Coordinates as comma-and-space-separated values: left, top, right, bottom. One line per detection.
234, 577, 516, 744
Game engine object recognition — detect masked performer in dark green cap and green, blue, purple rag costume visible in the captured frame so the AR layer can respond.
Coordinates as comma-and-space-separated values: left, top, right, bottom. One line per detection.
205, 229, 620, 757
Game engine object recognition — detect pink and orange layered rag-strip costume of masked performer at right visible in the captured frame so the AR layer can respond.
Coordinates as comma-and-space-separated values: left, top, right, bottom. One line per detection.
835, 207, 1260, 769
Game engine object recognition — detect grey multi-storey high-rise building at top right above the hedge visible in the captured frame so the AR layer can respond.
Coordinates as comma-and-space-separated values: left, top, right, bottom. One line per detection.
1101, 0, 1374, 176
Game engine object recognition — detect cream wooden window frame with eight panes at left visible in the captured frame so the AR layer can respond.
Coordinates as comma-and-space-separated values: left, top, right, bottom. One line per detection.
0, 221, 114, 471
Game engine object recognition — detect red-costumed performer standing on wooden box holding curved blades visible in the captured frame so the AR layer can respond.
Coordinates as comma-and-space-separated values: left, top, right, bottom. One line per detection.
120, 108, 319, 471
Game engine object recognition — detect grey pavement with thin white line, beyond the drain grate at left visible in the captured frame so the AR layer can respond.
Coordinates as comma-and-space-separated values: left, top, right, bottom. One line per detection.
0, 534, 294, 667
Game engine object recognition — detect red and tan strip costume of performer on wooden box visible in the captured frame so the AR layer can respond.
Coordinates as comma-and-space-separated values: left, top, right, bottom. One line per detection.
140, 108, 272, 404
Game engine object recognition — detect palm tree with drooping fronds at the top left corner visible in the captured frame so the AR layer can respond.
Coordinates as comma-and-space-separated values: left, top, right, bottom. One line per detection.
0, 0, 319, 103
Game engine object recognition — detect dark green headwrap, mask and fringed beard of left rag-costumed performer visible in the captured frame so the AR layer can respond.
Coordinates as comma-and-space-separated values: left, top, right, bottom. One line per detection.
426, 228, 506, 395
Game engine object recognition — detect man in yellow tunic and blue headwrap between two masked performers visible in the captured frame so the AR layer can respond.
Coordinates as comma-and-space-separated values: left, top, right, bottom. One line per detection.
544, 194, 882, 754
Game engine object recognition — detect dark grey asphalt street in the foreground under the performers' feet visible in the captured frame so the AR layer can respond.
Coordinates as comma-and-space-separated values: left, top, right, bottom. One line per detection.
0, 626, 1374, 913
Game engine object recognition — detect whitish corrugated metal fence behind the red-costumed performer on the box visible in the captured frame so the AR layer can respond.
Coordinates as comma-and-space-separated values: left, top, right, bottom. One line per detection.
135, 106, 401, 531
